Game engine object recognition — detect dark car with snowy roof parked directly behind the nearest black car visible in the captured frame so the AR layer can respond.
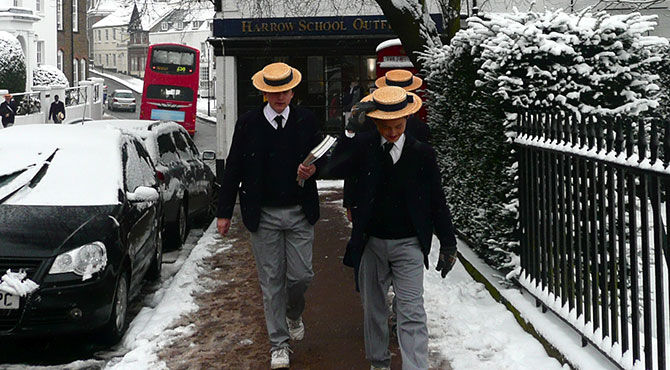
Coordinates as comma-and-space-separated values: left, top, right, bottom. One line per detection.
86, 120, 218, 249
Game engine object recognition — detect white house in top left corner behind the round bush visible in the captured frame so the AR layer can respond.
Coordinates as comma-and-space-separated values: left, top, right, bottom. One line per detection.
0, 0, 58, 90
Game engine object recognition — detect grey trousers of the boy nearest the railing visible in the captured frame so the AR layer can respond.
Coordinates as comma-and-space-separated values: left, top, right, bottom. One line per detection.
358, 237, 428, 370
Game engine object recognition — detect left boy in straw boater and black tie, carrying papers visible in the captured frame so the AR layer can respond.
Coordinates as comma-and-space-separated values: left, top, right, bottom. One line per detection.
217, 63, 322, 369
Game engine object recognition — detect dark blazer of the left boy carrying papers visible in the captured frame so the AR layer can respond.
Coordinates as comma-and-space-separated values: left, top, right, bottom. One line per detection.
216, 105, 323, 232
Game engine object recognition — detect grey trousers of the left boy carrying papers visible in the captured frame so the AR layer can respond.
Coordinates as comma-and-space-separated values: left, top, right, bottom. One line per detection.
251, 206, 314, 350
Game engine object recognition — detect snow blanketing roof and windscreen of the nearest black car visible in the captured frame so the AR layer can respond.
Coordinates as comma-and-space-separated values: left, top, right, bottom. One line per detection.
0, 124, 123, 206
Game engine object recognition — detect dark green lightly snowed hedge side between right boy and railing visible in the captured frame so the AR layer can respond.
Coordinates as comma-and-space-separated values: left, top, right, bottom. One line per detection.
426, 45, 517, 267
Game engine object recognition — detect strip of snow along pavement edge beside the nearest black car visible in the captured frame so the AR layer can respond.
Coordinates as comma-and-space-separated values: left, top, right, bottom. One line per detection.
107, 222, 231, 369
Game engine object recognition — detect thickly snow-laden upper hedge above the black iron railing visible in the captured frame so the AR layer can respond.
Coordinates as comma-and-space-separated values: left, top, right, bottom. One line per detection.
452, 10, 668, 115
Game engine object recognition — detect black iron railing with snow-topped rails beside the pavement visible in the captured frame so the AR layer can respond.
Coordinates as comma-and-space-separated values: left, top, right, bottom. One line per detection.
515, 111, 670, 369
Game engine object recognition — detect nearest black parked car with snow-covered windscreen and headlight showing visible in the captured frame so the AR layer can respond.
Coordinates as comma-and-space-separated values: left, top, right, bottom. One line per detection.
0, 125, 162, 343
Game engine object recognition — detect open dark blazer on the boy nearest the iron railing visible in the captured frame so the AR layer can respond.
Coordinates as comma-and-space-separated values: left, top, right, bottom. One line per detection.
323, 131, 456, 269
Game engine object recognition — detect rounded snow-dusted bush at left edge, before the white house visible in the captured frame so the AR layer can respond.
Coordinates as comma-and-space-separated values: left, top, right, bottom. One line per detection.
0, 31, 26, 93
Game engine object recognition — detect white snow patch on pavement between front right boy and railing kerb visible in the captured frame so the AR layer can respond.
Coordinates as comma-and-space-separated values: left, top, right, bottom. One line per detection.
424, 238, 569, 370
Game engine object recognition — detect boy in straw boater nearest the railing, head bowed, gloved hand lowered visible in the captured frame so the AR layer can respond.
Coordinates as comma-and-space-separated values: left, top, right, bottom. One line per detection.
323, 86, 457, 369
